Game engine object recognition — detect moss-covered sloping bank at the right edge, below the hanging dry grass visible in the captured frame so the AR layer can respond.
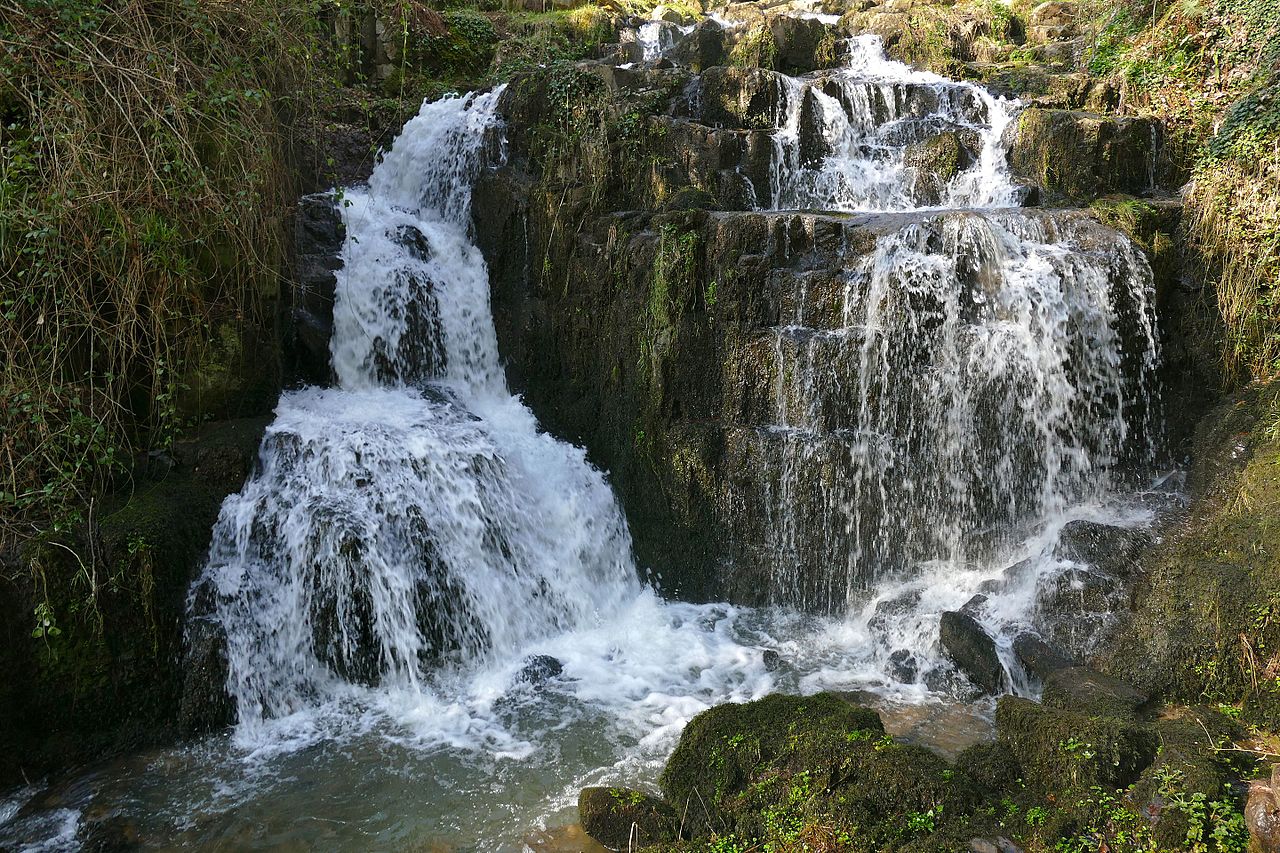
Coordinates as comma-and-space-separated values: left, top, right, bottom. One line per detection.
1108, 386, 1280, 729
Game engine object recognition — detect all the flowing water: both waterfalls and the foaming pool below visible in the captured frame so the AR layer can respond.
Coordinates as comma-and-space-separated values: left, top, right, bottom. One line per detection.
0, 29, 1172, 852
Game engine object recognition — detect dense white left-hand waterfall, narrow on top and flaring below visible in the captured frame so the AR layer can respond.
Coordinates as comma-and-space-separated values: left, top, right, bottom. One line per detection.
192, 88, 639, 727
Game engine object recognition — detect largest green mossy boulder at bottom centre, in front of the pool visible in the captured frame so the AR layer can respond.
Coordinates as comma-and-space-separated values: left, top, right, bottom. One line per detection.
660, 693, 979, 849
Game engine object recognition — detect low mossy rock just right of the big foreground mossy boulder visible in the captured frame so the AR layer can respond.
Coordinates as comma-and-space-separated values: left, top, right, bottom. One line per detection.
996, 695, 1160, 797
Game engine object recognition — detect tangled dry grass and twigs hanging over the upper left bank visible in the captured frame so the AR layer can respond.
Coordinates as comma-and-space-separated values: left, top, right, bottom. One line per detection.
0, 0, 323, 538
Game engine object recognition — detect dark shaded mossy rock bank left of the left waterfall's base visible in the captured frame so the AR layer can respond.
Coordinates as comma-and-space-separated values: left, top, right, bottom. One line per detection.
0, 418, 268, 784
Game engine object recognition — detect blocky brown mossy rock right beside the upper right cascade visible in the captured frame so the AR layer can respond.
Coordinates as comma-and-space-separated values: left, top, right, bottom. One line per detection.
1006, 108, 1161, 200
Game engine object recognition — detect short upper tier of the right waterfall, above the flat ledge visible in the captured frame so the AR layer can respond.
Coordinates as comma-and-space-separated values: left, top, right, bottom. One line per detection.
675, 35, 1024, 211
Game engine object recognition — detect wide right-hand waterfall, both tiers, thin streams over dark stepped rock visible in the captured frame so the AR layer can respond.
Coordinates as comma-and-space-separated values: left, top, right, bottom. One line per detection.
732, 35, 1160, 617
